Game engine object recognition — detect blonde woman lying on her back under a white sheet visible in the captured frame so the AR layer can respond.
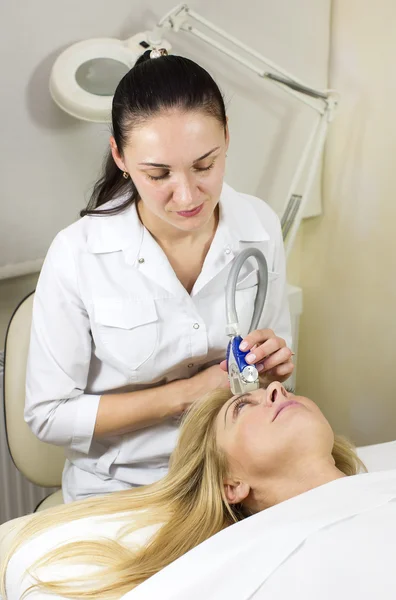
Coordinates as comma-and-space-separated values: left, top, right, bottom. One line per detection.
2, 382, 396, 600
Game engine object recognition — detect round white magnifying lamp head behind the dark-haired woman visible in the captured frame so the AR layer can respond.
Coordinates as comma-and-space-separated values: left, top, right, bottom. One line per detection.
50, 33, 171, 123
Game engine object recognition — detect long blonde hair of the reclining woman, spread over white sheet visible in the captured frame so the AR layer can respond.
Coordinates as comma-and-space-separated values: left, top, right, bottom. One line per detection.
0, 390, 364, 599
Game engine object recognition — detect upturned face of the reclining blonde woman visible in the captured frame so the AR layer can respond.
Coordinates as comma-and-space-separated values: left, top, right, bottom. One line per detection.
216, 382, 334, 502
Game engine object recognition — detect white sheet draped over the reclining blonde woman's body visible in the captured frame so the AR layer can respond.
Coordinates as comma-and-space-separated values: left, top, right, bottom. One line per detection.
123, 471, 396, 600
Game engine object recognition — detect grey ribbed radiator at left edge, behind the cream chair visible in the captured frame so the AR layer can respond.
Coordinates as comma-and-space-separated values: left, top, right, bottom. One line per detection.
0, 352, 53, 525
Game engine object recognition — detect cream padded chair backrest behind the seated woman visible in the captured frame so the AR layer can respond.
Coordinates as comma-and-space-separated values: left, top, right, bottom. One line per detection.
4, 292, 65, 510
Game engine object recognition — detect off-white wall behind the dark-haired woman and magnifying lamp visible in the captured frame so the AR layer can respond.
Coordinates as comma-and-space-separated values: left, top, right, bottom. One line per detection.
0, 0, 330, 278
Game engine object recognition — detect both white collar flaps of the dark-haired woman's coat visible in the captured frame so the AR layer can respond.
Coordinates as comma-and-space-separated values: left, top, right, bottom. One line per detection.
85, 183, 270, 260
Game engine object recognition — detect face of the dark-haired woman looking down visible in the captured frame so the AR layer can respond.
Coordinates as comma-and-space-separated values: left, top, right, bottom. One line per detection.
111, 110, 228, 232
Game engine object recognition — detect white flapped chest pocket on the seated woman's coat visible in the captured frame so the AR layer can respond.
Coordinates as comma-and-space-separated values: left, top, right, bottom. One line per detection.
92, 298, 158, 371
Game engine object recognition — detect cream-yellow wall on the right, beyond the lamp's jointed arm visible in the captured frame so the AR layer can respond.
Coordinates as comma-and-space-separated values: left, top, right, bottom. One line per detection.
298, 0, 396, 444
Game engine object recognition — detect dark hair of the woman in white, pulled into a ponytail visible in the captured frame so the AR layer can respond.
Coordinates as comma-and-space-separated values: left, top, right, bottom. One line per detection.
80, 50, 227, 217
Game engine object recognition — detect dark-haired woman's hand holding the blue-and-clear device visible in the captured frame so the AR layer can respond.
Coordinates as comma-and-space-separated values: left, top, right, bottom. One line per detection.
220, 329, 294, 384
